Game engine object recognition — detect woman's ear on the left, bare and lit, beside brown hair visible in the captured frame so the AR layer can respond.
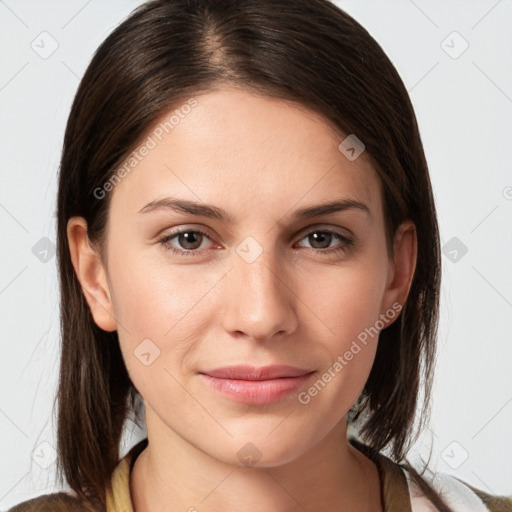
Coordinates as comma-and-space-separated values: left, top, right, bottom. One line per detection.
67, 217, 117, 331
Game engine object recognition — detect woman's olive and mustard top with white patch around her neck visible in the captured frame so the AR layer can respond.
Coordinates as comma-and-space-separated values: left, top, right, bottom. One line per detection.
8, 438, 512, 512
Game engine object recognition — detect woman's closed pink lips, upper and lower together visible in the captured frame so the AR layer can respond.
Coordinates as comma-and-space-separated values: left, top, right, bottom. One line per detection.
200, 365, 315, 405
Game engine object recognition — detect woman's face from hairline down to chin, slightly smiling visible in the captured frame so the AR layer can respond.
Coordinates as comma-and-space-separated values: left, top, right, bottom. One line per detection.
73, 87, 413, 466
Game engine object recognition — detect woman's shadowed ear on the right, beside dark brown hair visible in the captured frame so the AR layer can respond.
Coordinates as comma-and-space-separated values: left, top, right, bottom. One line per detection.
382, 220, 418, 313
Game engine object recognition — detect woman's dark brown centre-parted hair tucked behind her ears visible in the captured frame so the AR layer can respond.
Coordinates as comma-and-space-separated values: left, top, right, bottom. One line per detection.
56, 0, 450, 512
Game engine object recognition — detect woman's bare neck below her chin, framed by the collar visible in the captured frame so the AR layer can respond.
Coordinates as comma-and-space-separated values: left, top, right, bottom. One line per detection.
130, 407, 382, 512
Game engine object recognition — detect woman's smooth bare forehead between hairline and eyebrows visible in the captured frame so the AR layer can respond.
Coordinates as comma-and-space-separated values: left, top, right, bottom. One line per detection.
112, 87, 381, 220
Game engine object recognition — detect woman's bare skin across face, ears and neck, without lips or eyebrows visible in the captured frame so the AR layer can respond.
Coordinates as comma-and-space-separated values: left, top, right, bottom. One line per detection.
68, 85, 416, 512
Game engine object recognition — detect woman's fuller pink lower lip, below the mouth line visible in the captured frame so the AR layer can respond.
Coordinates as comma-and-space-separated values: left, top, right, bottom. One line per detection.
200, 372, 314, 405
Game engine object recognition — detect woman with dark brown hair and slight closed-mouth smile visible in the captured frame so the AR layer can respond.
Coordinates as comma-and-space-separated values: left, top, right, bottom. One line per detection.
8, 0, 512, 512
